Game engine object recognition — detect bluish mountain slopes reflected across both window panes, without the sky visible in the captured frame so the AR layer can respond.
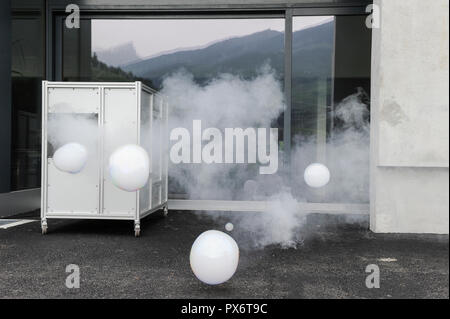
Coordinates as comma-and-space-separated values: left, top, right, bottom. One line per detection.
92, 22, 334, 141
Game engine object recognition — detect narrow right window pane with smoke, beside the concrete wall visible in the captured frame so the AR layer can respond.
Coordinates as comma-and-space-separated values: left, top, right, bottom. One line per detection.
291, 16, 371, 203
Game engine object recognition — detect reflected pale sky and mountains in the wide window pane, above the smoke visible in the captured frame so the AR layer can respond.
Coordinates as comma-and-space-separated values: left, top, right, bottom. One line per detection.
92, 19, 284, 88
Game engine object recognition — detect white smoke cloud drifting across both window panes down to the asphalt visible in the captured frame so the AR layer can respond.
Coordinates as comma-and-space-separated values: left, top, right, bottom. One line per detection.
162, 66, 369, 248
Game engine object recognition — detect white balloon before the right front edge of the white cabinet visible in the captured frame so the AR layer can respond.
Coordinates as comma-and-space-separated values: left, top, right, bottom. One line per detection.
109, 144, 150, 192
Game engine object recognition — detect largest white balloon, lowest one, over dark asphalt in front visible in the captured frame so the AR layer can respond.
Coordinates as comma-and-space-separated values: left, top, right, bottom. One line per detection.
190, 230, 239, 285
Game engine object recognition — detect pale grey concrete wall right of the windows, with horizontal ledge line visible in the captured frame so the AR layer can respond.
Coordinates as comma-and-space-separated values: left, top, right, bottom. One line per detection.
371, 0, 449, 234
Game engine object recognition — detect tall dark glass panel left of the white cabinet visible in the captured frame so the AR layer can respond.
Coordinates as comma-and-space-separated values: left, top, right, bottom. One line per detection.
11, 1, 45, 190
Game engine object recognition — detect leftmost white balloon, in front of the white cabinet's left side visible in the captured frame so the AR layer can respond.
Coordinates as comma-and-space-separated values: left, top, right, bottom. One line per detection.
53, 143, 88, 174
